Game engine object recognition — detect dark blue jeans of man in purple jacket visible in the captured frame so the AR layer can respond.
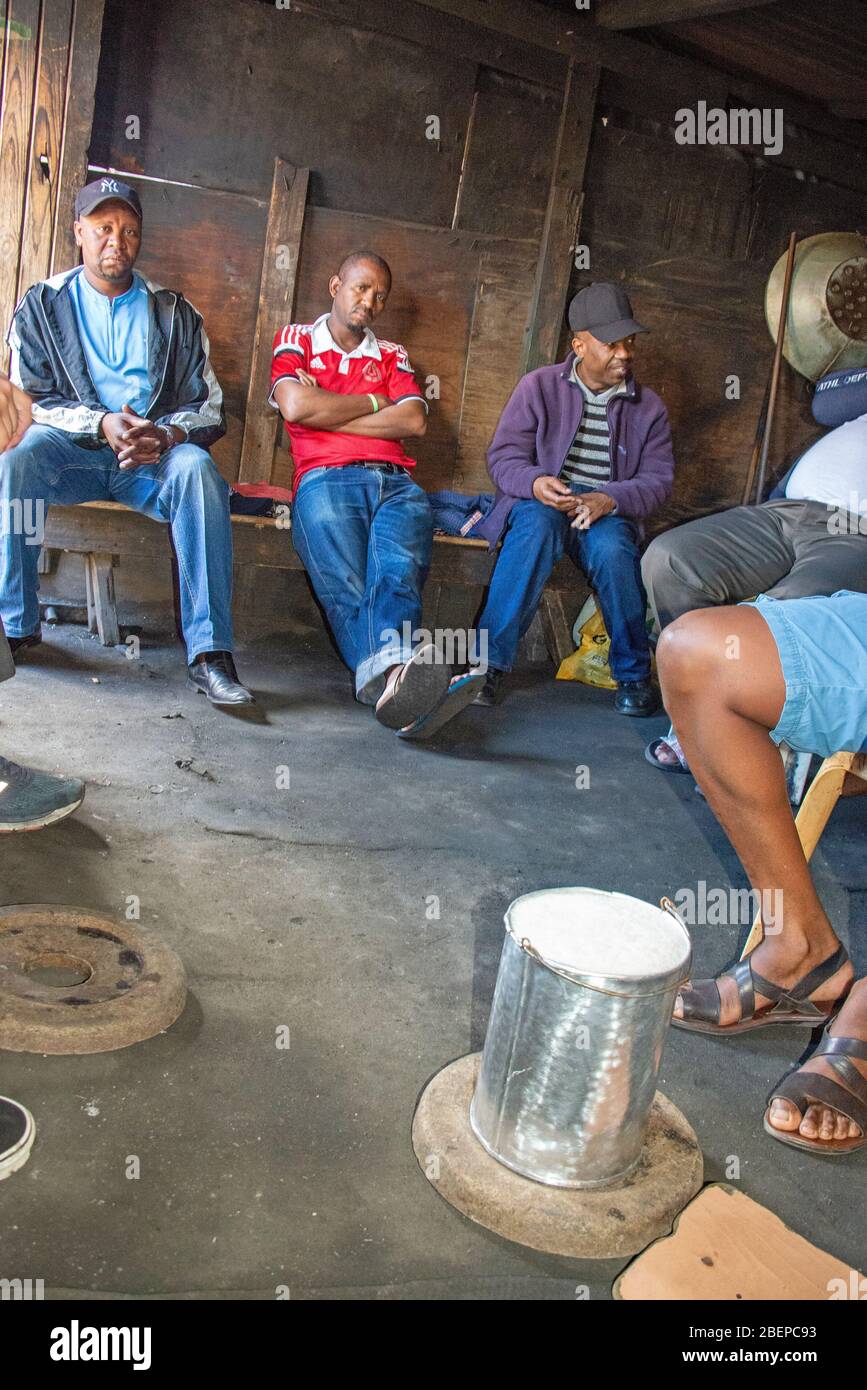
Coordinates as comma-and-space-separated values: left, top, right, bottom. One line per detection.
478, 500, 650, 682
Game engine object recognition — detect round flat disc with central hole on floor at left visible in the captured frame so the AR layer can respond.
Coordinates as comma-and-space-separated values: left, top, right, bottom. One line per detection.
0, 904, 186, 1054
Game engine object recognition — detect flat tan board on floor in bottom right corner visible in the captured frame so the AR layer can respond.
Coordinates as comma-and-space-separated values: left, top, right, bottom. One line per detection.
614, 1183, 857, 1302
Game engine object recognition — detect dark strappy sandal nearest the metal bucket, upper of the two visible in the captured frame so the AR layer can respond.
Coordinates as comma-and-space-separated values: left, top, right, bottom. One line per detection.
671, 945, 849, 1037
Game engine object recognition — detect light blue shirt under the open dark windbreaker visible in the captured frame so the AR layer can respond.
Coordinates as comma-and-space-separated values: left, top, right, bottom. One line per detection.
69, 271, 153, 416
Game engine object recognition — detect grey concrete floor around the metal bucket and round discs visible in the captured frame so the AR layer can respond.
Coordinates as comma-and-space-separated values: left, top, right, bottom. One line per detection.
0, 613, 867, 1300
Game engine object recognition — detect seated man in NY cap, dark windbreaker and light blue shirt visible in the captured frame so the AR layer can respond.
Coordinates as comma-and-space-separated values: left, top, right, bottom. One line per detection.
0, 175, 253, 705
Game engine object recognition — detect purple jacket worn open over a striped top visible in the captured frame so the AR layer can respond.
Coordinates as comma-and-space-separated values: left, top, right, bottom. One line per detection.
475, 353, 674, 549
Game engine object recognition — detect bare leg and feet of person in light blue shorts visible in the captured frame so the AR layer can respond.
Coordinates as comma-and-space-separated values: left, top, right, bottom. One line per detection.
657, 606, 867, 1138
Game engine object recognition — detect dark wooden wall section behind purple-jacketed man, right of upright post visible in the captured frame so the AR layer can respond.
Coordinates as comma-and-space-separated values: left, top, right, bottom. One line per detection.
561, 75, 867, 530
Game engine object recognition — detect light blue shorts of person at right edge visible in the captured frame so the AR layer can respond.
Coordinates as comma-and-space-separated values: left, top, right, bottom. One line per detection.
745, 589, 867, 758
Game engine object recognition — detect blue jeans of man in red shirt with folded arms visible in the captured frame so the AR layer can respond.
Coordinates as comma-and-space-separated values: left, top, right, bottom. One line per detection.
292, 463, 434, 705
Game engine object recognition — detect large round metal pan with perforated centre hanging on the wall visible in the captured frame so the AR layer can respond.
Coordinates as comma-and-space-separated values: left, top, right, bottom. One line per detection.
764, 232, 867, 381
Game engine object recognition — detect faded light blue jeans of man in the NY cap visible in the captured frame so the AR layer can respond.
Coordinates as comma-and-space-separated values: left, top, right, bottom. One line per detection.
0, 425, 233, 662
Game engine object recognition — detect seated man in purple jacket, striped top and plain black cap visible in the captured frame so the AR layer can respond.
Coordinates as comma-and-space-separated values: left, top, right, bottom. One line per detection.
474, 282, 674, 716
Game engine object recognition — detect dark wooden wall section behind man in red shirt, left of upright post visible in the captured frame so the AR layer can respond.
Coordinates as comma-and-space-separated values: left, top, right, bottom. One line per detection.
92, 0, 563, 492
